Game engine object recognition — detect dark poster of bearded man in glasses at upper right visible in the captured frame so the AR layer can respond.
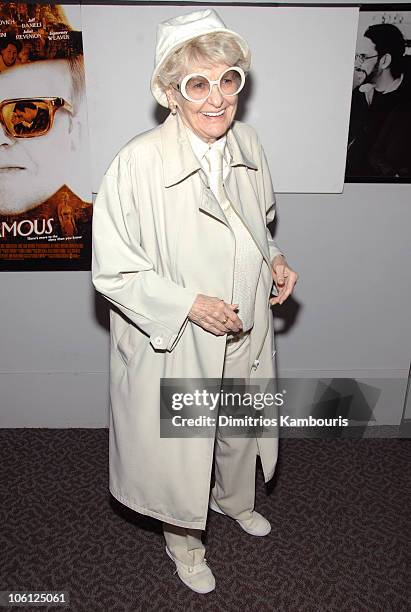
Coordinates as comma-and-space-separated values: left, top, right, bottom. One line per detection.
345, 4, 411, 183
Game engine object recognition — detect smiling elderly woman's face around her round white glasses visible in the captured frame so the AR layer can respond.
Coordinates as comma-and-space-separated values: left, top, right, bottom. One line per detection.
166, 64, 238, 144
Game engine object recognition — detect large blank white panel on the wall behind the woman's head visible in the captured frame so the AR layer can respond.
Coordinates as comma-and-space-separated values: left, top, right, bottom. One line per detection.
82, 5, 358, 193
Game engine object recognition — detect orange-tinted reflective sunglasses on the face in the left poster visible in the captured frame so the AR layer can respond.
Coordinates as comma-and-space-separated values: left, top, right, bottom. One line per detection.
0, 97, 73, 138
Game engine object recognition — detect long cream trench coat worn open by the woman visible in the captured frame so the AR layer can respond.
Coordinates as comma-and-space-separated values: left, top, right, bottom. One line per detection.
92, 115, 286, 529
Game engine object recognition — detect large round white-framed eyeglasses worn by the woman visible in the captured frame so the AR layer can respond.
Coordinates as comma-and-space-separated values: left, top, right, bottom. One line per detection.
173, 66, 245, 102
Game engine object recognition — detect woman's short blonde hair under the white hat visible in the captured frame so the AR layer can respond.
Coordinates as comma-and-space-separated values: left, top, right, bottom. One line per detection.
157, 32, 250, 90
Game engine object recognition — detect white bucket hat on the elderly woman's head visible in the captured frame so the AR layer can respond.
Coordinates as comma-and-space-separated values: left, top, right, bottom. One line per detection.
150, 9, 251, 108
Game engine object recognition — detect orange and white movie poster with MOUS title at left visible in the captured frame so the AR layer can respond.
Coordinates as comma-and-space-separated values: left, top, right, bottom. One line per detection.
0, 2, 92, 271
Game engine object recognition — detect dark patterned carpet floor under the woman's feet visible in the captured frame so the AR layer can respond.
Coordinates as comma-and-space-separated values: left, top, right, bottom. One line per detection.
0, 429, 411, 612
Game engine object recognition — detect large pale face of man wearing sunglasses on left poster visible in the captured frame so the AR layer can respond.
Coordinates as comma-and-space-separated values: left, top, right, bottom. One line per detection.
0, 60, 74, 214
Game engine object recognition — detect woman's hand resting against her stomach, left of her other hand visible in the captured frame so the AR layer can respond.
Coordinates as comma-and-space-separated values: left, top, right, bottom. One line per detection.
188, 293, 243, 336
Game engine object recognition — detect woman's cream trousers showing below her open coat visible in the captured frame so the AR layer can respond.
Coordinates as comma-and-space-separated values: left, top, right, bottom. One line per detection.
163, 332, 258, 565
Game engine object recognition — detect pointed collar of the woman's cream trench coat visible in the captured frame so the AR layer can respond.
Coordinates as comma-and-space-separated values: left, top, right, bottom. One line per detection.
161, 113, 258, 187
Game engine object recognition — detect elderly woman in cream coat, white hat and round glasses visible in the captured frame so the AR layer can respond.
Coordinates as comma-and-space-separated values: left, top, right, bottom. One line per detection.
93, 10, 297, 593
